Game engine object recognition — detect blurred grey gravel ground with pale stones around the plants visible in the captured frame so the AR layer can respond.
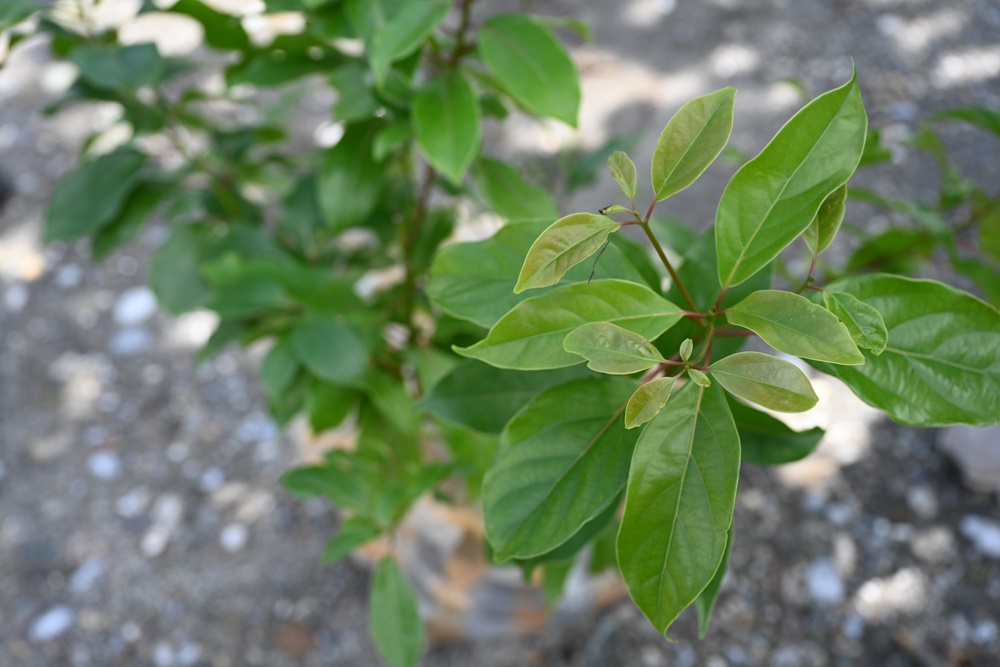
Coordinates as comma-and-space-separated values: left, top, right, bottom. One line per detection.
0, 0, 1000, 667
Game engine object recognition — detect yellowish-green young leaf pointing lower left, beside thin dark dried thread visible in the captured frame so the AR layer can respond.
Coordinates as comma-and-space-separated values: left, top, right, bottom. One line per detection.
514, 213, 619, 294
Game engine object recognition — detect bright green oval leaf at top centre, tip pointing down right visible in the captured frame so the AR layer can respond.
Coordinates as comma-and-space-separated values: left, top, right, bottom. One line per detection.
479, 14, 580, 127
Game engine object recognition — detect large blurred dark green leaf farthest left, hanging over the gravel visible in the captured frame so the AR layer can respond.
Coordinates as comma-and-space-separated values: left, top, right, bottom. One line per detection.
45, 148, 146, 243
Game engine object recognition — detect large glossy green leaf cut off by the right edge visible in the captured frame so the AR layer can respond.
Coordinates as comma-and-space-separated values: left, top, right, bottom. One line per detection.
813, 274, 1000, 426
